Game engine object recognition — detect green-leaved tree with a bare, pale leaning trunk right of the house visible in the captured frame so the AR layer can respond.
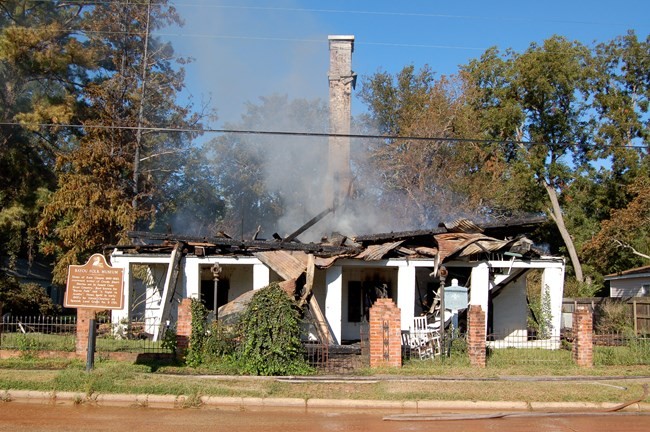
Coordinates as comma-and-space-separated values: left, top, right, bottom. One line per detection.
463, 36, 591, 282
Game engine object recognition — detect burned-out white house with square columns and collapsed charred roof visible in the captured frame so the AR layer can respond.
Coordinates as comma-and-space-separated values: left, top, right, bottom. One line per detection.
111, 220, 565, 347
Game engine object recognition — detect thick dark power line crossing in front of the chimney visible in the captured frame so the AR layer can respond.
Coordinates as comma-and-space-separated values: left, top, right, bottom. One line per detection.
0, 121, 648, 149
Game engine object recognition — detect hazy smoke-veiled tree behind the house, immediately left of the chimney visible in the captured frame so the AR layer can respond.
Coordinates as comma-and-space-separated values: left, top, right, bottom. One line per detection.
203, 95, 328, 238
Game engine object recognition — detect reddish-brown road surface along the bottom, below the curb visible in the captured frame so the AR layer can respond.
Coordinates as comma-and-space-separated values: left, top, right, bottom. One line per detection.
0, 402, 650, 432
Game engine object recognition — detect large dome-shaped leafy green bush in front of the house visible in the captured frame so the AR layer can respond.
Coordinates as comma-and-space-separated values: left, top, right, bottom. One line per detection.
237, 283, 311, 375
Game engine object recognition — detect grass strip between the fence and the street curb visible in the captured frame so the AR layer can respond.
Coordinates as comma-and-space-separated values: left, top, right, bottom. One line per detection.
0, 359, 650, 402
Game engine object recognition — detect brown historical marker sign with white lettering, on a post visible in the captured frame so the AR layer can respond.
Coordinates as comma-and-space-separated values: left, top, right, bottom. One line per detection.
63, 254, 124, 309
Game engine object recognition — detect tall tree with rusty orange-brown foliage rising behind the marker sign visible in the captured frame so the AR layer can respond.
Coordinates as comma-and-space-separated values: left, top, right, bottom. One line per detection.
38, 0, 200, 282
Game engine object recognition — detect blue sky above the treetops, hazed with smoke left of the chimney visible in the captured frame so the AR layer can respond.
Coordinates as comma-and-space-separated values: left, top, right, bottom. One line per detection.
157, 0, 650, 128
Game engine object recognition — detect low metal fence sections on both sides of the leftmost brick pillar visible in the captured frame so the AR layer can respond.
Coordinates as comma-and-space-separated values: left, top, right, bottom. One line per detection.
0, 315, 176, 353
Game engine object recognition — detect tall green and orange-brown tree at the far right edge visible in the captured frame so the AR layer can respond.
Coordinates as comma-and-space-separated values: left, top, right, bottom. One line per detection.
584, 32, 650, 274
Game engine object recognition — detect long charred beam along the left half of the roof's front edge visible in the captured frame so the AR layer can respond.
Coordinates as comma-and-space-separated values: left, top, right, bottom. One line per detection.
128, 231, 361, 256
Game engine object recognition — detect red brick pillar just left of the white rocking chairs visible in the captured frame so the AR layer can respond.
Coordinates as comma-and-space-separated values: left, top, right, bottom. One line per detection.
369, 299, 402, 368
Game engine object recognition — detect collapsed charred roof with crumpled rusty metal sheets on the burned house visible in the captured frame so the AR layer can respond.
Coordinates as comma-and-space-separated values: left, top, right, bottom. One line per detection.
112, 214, 545, 271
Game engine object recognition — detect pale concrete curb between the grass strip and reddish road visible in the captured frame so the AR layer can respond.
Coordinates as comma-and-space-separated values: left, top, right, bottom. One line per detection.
0, 390, 650, 413
